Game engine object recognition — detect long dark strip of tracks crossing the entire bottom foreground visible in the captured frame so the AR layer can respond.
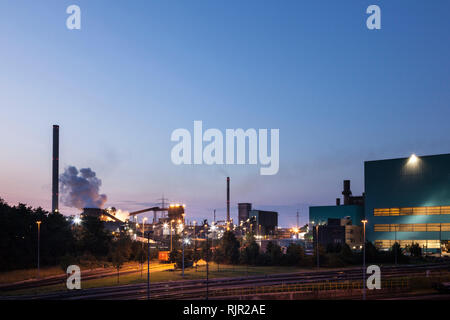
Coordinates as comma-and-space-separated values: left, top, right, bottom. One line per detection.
2, 264, 450, 300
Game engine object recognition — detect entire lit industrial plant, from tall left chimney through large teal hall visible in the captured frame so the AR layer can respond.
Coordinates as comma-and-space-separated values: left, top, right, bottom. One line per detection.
52, 125, 450, 254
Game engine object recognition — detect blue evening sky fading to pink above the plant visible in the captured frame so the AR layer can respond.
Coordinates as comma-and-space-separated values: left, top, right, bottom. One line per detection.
0, 0, 450, 227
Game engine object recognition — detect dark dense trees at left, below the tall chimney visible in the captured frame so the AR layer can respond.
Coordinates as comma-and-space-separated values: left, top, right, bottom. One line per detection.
0, 198, 153, 271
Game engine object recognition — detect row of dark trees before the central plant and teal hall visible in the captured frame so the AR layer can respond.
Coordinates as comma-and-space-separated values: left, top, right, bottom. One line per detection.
170, 231, 428, 267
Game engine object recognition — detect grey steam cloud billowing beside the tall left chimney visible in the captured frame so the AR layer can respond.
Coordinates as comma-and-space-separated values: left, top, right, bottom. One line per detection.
59, 166, 107, 209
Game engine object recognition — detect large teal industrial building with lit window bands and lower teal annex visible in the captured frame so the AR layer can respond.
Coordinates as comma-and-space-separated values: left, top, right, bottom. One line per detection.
309, 154, 450, 252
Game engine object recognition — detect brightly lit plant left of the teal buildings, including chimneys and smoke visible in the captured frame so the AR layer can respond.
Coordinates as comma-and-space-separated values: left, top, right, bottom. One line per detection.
48, 125, 306, 260
